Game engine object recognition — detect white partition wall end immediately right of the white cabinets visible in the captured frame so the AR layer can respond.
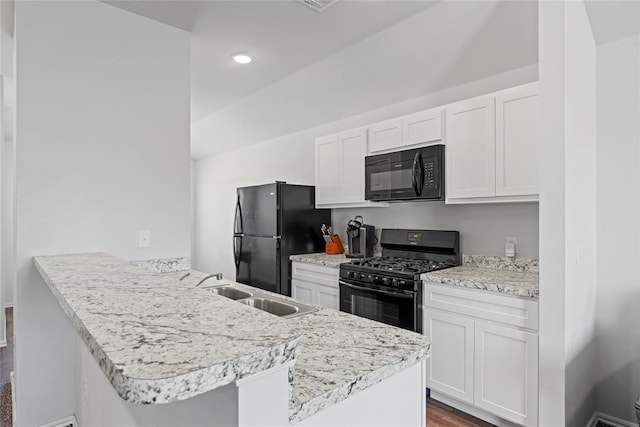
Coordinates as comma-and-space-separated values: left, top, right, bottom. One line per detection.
539, 1, 600, 426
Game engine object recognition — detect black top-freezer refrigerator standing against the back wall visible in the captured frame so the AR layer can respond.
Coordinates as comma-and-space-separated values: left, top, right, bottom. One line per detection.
233, 182, 331, 296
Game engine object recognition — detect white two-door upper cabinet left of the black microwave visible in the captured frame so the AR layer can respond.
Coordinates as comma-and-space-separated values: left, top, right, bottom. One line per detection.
316, 128, 388, 208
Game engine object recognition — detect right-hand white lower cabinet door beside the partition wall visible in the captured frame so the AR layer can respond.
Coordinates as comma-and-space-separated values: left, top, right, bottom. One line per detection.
472, 321, 538, 426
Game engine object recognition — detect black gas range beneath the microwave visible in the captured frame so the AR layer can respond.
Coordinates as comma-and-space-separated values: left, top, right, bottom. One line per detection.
340, 229, 461, 332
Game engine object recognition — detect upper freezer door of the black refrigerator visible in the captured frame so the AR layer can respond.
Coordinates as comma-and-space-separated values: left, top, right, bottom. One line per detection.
234, 183, 278, 236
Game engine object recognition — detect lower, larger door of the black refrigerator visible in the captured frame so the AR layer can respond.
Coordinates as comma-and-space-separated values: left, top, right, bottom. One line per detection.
235, 235, 280, 292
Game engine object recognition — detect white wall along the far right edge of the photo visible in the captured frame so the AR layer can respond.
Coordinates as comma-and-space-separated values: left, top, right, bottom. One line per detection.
596, 36, 640, 422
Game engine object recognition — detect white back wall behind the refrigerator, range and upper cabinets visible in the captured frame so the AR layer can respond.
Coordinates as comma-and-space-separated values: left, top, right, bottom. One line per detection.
193, 66, 538, 278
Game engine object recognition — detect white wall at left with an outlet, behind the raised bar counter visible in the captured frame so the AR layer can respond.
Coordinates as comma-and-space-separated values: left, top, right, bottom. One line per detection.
15, 1, 190, 425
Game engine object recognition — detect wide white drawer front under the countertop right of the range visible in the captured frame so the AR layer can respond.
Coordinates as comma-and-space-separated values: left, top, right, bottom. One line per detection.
424, 284, 538, 331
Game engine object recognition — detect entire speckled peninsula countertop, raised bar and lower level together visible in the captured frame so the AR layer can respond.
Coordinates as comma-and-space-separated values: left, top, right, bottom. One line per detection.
35, 254, 430, 423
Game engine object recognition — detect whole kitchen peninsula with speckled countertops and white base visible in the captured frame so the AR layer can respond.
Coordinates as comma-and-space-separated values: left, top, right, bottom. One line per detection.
34, 253, 430, 426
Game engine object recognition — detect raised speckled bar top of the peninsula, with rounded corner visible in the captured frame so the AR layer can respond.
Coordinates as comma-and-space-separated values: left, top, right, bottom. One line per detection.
34, 254, 302, 403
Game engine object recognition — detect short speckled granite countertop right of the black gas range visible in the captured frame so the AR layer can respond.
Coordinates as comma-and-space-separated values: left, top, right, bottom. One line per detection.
420, 255, 539, 298
